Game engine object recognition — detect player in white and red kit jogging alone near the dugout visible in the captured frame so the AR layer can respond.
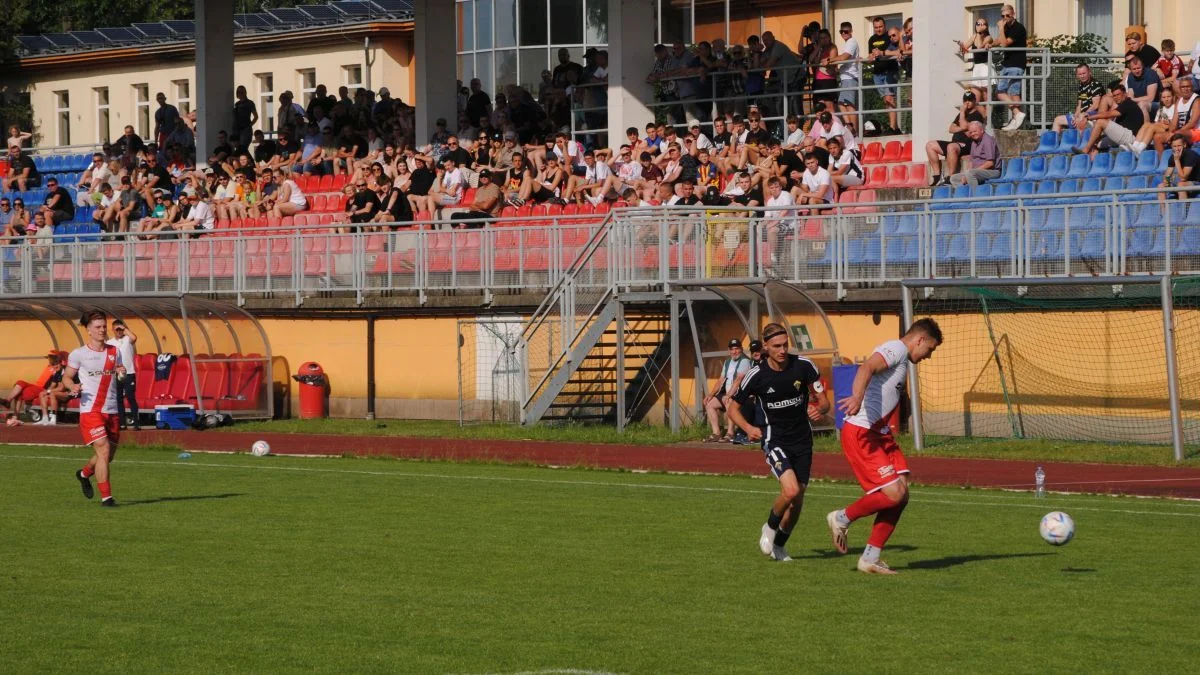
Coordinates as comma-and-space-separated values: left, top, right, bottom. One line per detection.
62, 310, 125, 507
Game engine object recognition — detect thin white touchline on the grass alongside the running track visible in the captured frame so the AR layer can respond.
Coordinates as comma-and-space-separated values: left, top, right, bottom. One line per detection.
0, 454, 1200, 518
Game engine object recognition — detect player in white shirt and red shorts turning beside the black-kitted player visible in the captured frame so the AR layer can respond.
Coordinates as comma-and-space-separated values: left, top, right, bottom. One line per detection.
826, 318, 942, 574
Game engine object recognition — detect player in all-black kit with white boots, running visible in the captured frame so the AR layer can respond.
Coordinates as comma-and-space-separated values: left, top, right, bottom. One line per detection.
728, 323, 829, 561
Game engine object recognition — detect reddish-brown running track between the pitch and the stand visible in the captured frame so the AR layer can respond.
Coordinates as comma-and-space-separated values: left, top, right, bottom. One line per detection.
0, 425, 1200, 498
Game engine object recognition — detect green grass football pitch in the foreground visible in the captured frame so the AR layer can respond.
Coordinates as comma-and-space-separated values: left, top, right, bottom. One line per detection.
0, 446, 1200, 674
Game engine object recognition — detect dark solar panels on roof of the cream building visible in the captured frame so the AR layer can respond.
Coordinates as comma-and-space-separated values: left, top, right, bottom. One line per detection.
17, 0, 413, 56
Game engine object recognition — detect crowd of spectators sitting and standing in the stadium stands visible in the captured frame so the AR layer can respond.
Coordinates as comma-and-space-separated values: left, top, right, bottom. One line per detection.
0, 5, 1200, 249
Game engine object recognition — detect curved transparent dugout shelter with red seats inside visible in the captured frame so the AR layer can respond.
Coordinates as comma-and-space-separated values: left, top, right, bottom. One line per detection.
0, 294, 275, 419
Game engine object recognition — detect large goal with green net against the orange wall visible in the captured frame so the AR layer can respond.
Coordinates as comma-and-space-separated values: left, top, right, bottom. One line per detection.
904, 277, 1200, 443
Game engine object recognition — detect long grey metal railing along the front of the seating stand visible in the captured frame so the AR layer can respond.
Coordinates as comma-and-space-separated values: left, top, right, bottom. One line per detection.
0, 187, 1200, 302
